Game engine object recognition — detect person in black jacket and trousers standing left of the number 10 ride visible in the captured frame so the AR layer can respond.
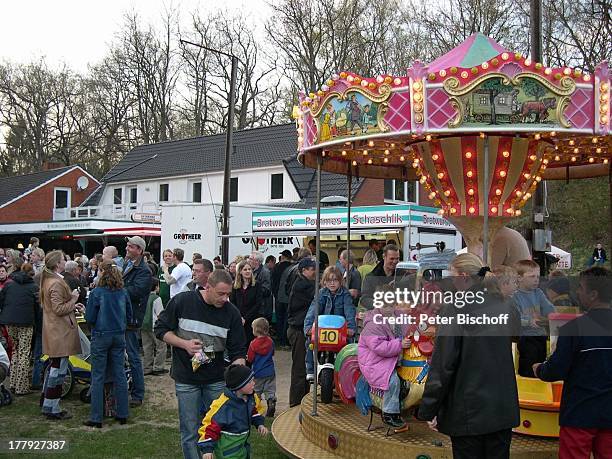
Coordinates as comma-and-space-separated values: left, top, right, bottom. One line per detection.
287, 257, 316, 407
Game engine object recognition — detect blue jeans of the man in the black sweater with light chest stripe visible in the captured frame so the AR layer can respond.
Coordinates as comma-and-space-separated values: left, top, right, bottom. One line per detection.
175, 381, 225, 459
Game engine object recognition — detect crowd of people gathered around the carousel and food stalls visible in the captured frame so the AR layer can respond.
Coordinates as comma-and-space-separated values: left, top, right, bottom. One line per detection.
0, 236, 612, 458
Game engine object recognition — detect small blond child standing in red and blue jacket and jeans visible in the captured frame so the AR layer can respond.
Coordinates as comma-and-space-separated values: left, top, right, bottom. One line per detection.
247, 317, 276, 418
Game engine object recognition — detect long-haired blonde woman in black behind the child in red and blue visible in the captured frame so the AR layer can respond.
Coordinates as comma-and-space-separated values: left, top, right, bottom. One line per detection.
230, 260, 263, 347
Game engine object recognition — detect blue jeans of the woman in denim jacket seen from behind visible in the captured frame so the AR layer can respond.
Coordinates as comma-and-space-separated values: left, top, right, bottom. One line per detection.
90, 334, 128, 422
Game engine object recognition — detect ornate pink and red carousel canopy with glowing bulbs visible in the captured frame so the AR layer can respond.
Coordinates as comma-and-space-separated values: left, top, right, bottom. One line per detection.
297, 34, 610, 207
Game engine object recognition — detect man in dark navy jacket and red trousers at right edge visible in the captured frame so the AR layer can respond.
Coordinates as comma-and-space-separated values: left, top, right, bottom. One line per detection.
533, 267, 612, 459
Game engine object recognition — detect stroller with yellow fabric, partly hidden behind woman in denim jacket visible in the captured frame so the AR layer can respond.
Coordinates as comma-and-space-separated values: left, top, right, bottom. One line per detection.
41, 327, 132, 403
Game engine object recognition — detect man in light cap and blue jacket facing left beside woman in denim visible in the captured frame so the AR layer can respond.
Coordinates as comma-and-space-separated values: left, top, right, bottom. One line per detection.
123, 236, 153, 407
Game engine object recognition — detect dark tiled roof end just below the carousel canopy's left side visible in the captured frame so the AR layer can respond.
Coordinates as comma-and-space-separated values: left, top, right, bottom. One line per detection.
283, 155, 364, 208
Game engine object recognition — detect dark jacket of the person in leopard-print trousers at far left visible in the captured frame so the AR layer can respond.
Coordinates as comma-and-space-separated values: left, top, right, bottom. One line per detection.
0, 271, 38, 327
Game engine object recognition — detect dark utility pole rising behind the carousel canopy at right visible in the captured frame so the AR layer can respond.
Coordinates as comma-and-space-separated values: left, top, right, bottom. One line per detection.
530, 0, 549, 274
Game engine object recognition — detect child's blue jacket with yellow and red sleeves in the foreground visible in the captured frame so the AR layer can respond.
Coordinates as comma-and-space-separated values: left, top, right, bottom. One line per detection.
198, 388, 264, 459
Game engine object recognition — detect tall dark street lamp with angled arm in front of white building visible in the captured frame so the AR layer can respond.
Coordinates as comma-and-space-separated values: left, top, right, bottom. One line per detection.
180, 40, 238, 265
